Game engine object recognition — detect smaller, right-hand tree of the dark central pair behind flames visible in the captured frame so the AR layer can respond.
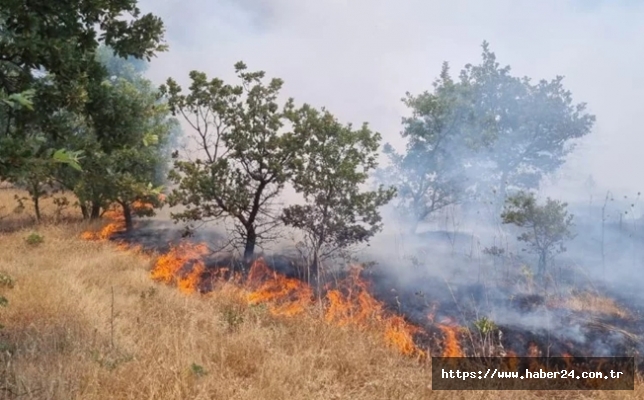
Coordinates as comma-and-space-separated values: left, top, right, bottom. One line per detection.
282, 107, 395, 274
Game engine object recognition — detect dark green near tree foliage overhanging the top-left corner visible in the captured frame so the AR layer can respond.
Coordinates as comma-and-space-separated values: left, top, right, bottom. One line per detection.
0, 0, 166, 184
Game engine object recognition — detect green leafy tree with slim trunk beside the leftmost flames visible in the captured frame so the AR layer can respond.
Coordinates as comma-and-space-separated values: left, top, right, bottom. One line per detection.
75, 65, 178, 230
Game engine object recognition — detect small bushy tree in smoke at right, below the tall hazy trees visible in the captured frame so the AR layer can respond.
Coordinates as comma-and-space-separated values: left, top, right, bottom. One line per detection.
501, 191, 575, 275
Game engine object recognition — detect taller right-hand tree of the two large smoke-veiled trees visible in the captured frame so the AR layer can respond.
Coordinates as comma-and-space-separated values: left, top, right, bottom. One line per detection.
458, 42, 595, 215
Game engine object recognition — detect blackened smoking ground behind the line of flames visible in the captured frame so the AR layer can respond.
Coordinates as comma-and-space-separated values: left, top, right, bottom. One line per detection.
112, 221, 644, 371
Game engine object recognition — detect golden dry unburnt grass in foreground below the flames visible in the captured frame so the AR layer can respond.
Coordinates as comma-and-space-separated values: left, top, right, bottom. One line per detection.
0, 189, 644, 400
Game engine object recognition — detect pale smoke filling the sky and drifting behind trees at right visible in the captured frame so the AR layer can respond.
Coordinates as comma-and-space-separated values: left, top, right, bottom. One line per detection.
131, 0, 644, 352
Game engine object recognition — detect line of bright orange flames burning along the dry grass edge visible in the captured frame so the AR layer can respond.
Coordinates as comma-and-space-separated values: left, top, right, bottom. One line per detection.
81, 208, 426, 358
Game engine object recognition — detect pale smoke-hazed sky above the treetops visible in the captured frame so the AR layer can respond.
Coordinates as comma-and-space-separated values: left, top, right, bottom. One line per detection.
140, 0, 644, 200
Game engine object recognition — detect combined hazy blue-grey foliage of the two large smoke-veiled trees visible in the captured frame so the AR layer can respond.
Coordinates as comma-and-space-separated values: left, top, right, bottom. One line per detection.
380, 42, 595, 231
